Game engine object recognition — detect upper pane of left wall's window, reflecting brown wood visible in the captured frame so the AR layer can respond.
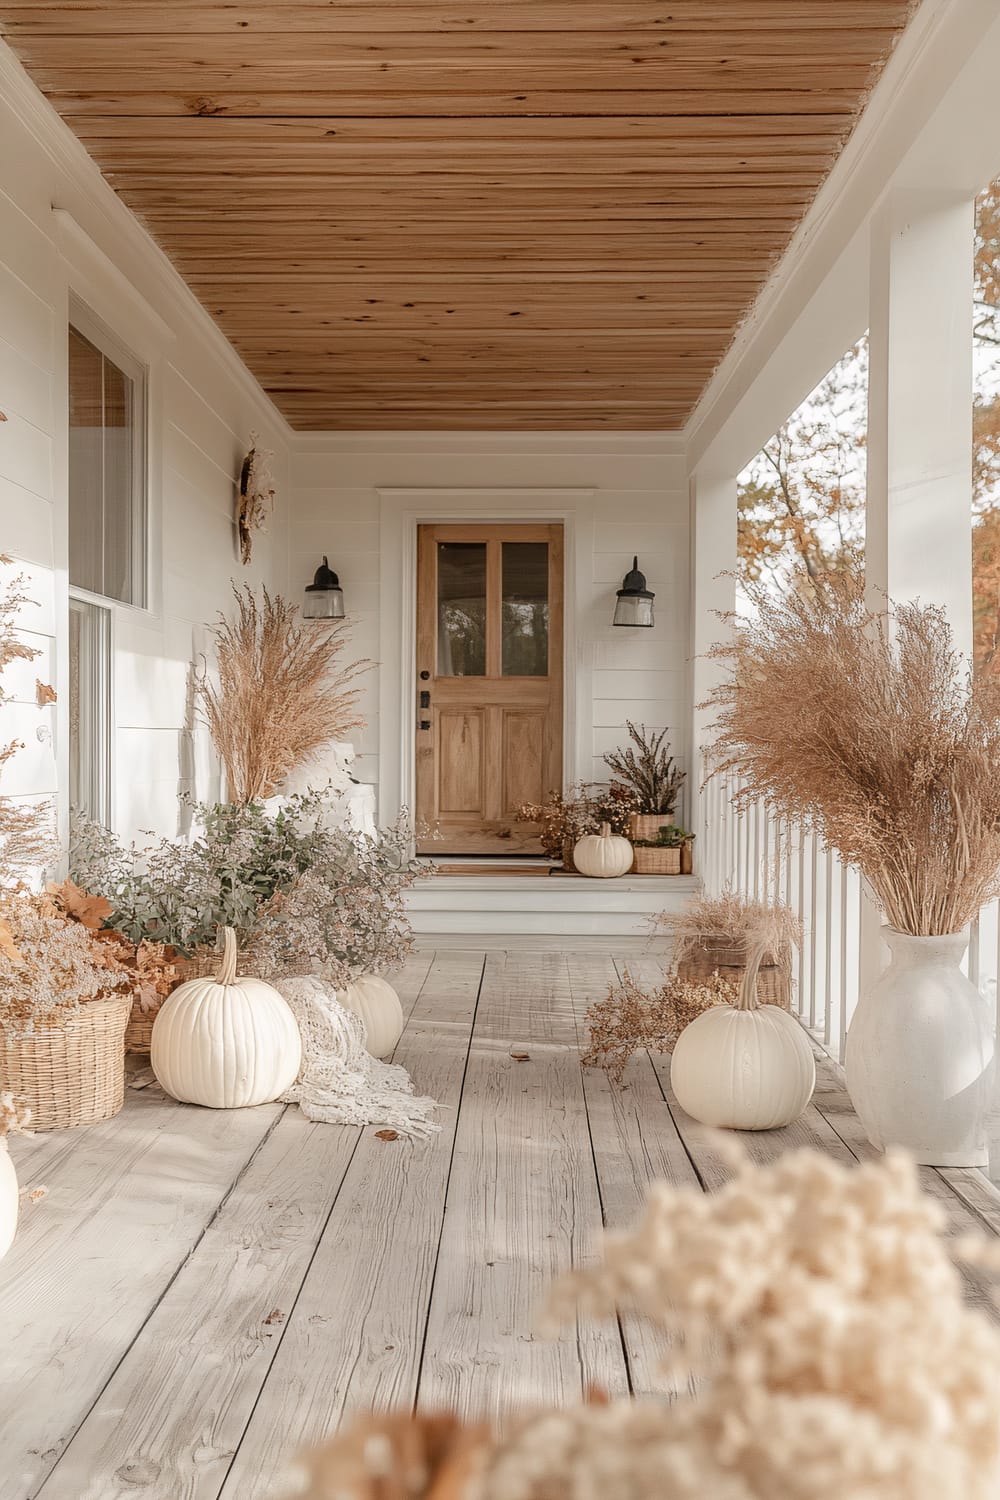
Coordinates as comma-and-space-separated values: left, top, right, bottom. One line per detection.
69, 329, 144, 605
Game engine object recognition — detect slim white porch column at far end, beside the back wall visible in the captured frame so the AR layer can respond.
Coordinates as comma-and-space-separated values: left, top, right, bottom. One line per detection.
688, 473, 736, 890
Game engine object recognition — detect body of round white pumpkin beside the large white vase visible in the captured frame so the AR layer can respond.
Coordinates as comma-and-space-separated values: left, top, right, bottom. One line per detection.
670, 1005, 816, 1130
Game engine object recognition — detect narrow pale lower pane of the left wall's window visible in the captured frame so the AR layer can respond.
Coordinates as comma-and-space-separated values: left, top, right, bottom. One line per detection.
69, 599, 111, 824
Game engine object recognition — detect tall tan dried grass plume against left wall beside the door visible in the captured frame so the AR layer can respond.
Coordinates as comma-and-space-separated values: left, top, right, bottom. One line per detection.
198, 587, 370, 803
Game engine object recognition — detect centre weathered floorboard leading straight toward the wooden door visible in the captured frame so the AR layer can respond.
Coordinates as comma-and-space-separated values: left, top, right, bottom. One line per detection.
420, 950, 628, 1418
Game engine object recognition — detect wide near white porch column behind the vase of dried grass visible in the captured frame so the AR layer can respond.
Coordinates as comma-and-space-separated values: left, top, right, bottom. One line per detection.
861, 191, 975, 986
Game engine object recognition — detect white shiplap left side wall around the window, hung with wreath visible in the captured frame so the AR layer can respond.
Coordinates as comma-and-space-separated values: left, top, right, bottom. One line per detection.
0, 44, 289, 836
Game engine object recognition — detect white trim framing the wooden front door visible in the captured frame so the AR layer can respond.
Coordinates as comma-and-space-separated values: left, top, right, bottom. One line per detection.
376, 486, 597, 822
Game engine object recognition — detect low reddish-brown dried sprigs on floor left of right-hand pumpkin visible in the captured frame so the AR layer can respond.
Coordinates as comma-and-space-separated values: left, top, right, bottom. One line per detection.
582, 969, 739, 1083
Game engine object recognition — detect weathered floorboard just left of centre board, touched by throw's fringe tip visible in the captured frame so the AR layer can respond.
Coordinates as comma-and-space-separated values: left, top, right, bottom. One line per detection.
223, 953, 483, 1500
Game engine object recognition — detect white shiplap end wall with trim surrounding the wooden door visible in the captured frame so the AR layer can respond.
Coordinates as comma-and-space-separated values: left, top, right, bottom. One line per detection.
289, 434, 690, 818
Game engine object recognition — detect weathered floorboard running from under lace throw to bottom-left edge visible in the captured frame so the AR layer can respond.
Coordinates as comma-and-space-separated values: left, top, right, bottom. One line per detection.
27, 956, 432, 1500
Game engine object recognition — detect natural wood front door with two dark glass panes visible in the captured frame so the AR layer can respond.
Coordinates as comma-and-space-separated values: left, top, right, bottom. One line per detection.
415, 525, 562, 854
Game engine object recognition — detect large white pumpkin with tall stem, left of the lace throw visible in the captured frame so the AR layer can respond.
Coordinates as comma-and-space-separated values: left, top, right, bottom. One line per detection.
150, 927, 301, 1110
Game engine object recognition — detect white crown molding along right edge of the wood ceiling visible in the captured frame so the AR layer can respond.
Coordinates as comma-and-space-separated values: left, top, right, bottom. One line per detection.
685, 0, 971, 467
